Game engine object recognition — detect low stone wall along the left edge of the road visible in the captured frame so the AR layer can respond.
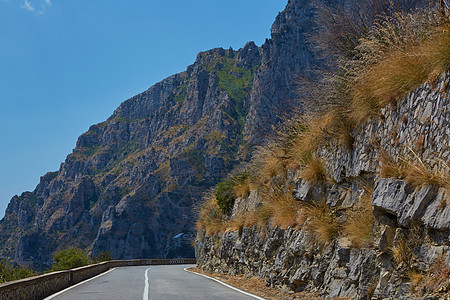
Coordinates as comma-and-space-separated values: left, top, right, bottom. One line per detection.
0, 258, 196, 300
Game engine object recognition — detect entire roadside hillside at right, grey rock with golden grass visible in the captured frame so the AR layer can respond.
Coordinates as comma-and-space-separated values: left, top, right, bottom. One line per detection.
196, 1, 450, 299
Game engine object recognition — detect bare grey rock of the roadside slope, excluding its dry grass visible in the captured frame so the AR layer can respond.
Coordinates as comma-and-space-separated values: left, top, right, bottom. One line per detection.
196, 72, 450, 299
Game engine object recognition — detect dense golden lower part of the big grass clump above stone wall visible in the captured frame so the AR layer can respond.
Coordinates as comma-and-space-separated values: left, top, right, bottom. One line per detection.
349, 24, 450, 124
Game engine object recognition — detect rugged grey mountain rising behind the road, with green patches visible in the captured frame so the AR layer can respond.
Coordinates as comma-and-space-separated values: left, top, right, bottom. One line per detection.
0, 0, 316, 264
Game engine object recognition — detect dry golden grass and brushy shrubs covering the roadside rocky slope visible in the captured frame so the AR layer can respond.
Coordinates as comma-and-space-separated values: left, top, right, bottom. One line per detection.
197, 1, 450, 247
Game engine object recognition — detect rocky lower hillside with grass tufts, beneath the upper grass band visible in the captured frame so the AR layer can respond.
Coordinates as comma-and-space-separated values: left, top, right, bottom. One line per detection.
196, 73, 450, 299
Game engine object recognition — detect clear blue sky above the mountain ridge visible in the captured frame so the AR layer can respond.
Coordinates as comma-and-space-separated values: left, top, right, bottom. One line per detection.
0, 0, 287, 218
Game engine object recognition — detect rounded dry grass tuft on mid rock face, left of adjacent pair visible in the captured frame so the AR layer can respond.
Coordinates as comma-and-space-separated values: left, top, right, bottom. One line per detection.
304, 203, 340, 246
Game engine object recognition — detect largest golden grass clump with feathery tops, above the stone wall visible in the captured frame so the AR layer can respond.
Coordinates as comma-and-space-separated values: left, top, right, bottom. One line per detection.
346, 11, 450, 124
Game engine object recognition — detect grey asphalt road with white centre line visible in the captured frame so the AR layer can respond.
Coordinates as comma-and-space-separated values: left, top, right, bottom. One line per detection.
46, 265, 255, 300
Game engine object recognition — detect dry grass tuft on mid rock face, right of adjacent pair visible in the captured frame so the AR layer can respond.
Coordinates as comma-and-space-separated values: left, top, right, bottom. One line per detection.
342, 192, 374, 248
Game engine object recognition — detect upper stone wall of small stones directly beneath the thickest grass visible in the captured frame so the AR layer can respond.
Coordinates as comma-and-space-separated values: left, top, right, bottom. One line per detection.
320, 72, 450, 182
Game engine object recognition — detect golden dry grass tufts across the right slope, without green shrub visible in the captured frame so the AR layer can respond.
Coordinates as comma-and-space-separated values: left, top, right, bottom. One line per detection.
198, 5, 450, 238
